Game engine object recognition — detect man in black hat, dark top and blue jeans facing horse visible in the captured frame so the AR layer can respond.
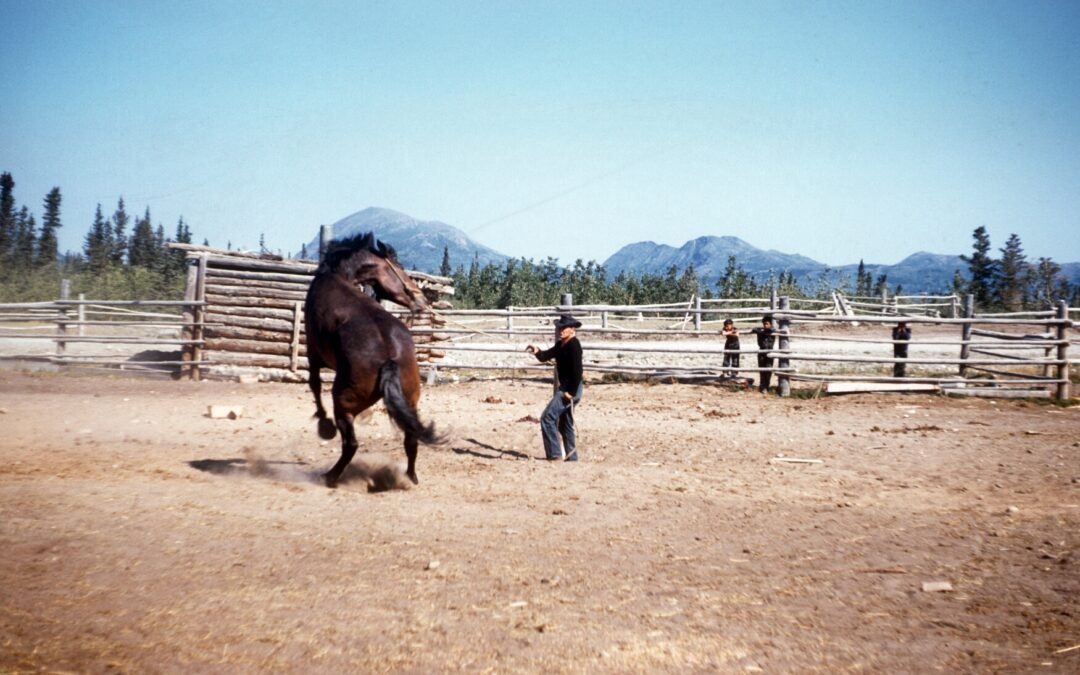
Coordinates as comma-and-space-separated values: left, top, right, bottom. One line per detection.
525, 314, 582, 461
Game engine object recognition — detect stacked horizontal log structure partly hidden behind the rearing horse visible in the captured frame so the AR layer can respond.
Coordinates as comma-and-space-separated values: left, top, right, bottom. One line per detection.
172, 244, 454, 380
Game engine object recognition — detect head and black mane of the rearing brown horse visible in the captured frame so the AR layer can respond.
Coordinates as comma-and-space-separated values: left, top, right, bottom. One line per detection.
319, 232, 428, 311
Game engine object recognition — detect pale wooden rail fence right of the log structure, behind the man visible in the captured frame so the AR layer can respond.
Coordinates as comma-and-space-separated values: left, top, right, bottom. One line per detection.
419, 296, 1072, 399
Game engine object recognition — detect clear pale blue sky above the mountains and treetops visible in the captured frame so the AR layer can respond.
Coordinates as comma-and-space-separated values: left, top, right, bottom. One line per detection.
0, 0, 1080, 265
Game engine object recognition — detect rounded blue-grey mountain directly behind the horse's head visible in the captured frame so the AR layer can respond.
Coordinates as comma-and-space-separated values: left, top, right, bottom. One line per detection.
306, 206, 508, 274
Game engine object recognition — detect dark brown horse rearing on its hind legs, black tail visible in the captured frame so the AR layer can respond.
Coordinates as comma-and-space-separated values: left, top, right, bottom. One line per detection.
303, 232, 442, 487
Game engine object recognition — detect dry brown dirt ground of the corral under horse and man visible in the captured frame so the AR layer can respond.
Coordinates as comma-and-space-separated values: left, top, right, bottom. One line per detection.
0, 369, 1080, 673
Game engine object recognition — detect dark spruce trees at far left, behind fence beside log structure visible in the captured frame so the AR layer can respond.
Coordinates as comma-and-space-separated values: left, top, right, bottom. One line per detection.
0, 172, 191, 302
